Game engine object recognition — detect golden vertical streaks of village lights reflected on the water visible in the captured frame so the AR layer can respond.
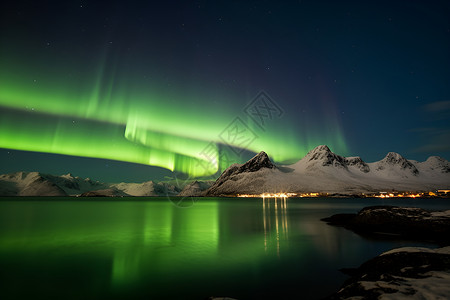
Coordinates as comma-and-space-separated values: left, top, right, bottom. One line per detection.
262, 196, 289, 256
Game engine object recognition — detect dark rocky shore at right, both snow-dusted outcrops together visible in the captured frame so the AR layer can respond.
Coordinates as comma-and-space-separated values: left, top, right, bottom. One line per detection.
322, 206, 450, 300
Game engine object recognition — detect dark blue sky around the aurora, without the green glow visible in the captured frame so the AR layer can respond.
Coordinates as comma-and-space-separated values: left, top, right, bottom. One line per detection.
0, 1, 450, 181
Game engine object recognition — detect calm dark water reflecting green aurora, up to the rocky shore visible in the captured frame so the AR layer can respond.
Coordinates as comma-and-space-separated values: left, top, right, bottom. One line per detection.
0, 197, 450, 300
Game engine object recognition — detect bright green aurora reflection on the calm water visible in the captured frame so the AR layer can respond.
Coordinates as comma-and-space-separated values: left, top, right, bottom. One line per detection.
111, 202, 220, 291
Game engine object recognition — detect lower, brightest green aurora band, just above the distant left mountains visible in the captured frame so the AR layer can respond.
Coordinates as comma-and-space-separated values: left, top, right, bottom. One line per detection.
0, 110, 217, 176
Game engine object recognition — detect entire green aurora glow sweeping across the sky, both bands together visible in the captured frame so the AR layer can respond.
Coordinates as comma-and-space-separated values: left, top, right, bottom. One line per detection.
0, 53, 346, 177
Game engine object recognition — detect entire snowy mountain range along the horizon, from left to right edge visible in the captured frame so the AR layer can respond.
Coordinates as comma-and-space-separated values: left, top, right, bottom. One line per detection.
0, 145, 450, 196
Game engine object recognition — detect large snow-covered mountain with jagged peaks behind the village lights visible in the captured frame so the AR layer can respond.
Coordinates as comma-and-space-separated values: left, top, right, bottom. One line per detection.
205, 145, 450, 196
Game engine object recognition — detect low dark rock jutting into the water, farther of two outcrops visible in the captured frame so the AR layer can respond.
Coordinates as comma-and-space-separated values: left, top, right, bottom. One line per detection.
322, 206, 450, 246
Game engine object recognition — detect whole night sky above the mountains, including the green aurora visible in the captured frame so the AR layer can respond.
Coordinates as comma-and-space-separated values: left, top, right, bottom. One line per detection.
0, 1, 450, 182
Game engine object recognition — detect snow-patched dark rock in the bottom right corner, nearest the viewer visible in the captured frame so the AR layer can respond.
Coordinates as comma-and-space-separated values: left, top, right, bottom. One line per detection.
325, 247, 450, 300
